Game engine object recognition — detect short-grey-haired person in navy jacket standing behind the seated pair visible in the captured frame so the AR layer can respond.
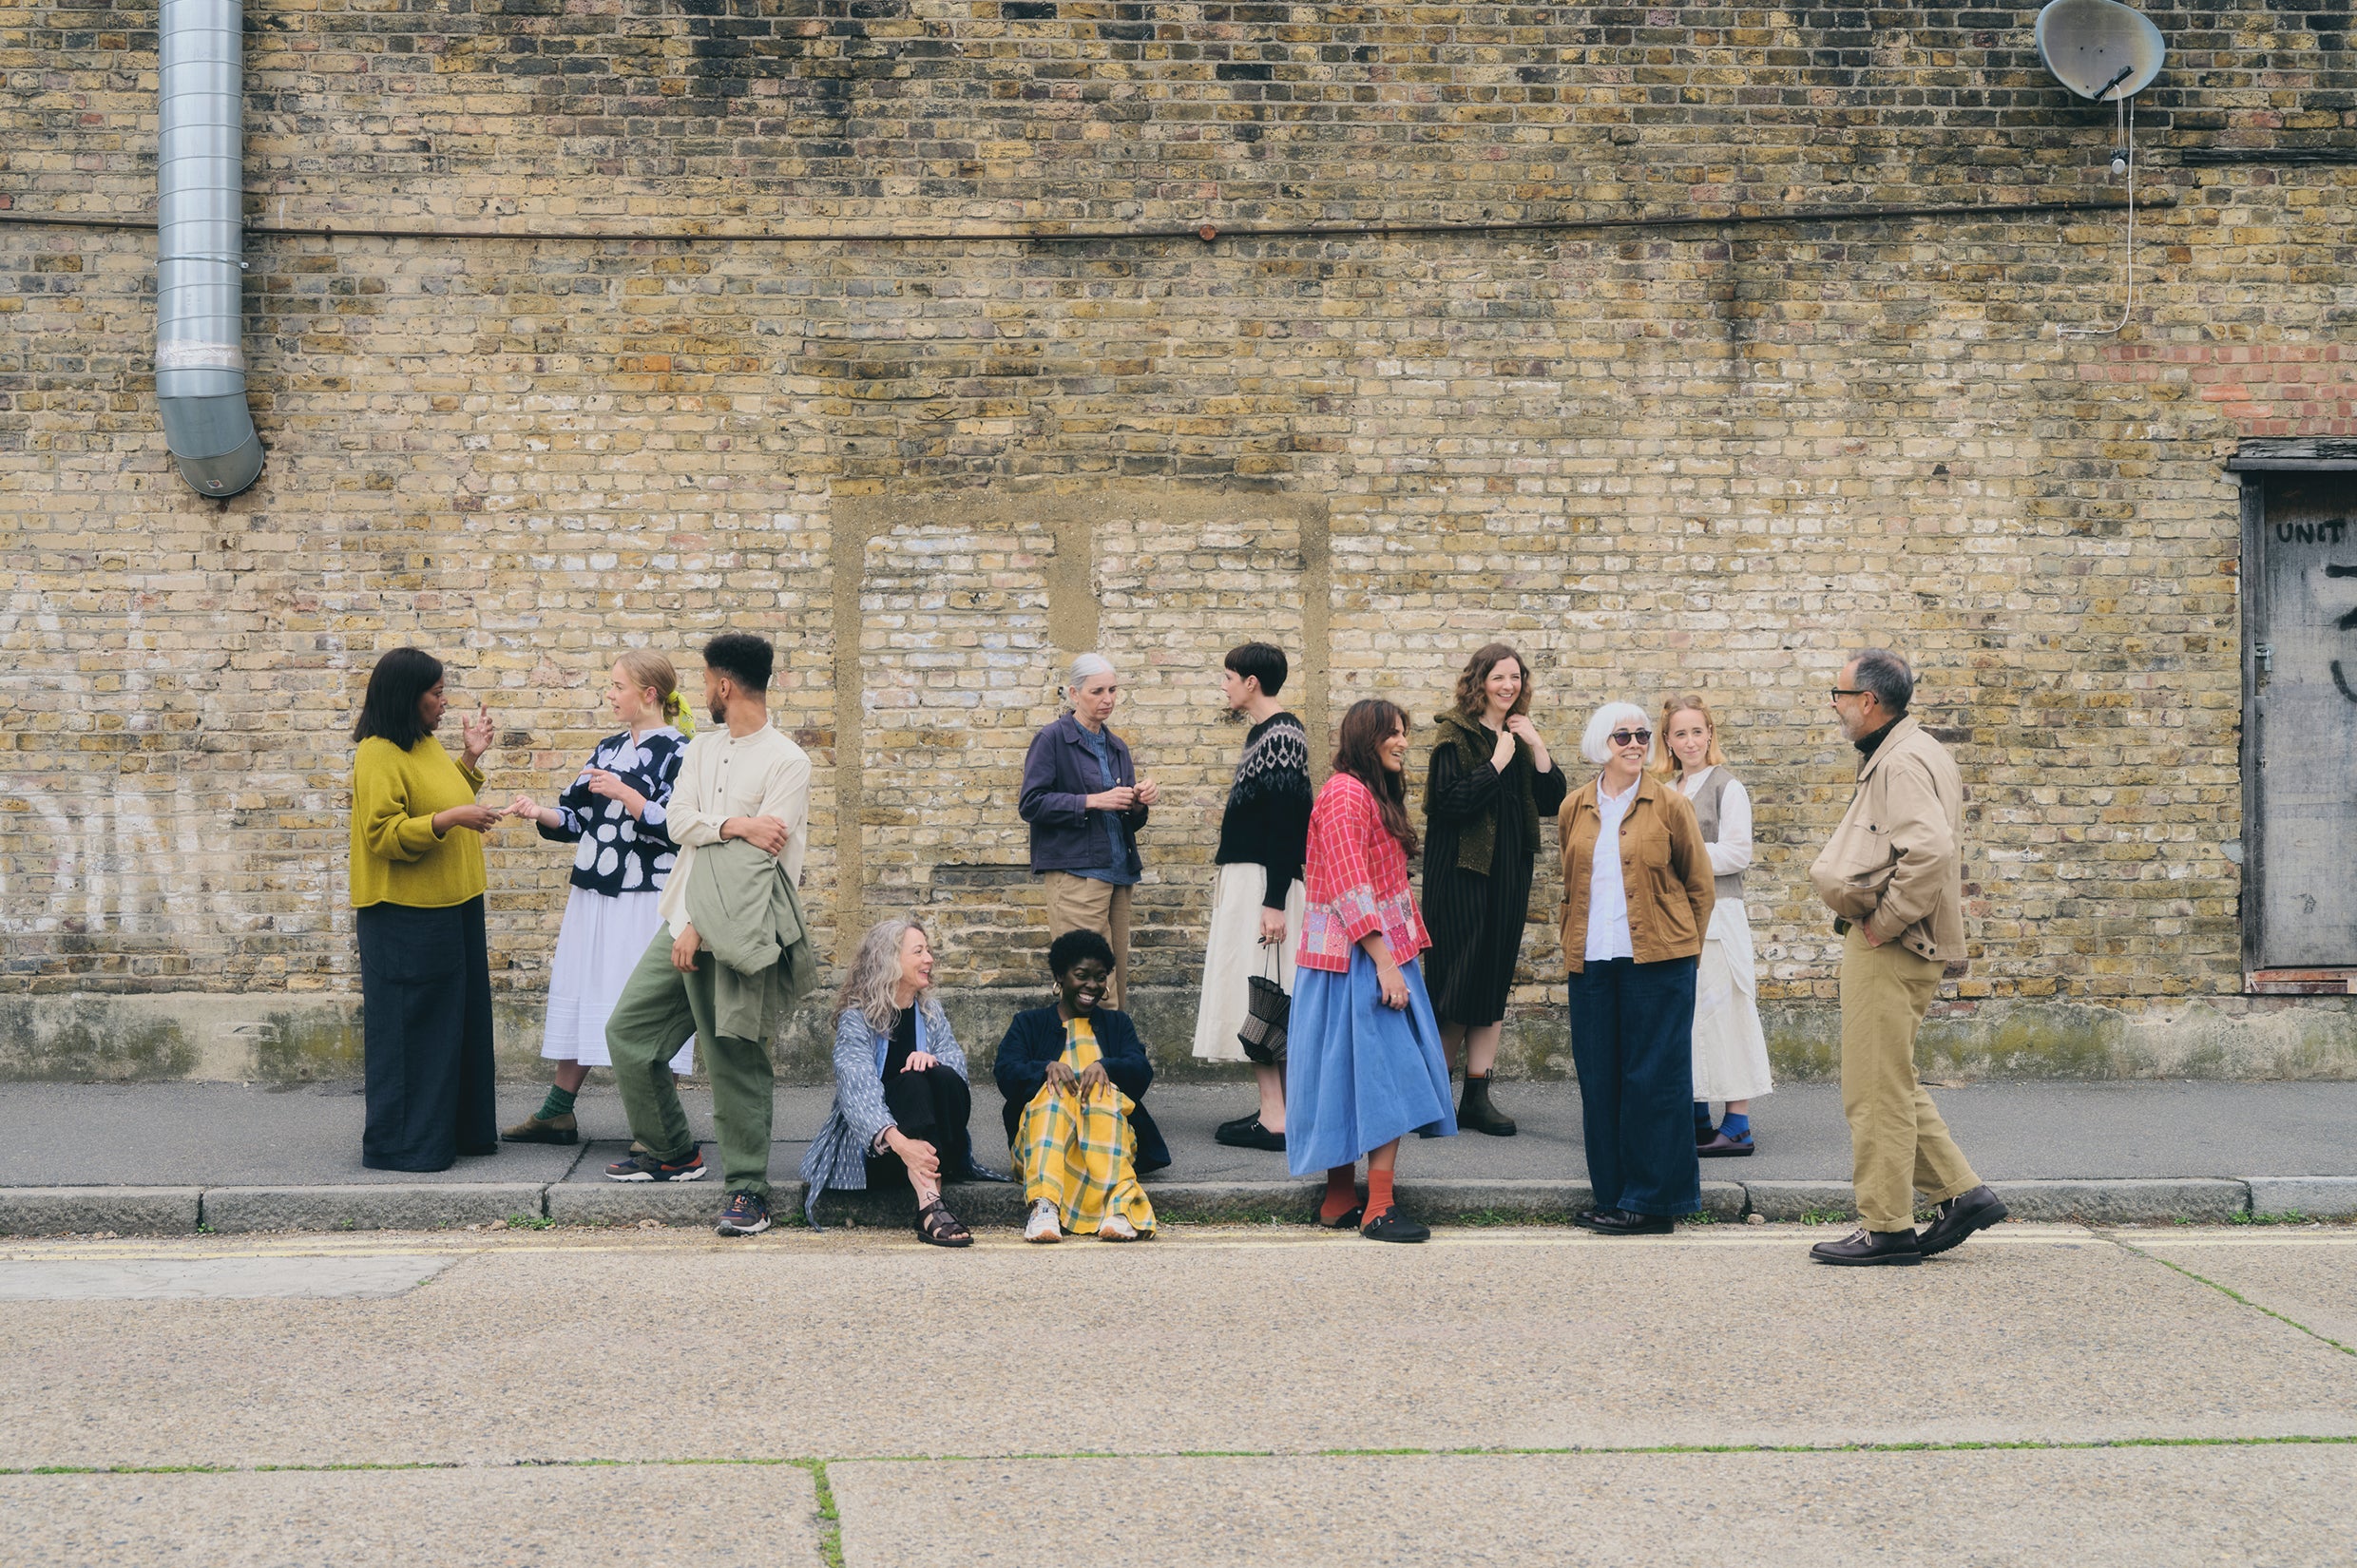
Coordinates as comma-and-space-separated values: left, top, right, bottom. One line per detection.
1016, 653, 1162, 1009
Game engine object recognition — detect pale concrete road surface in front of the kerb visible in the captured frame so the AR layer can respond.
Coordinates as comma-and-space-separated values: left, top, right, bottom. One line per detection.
0, 1226, 2357, 1568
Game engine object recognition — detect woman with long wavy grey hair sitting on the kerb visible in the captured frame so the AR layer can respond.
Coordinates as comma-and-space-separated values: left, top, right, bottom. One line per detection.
801, 917, 1004, 1248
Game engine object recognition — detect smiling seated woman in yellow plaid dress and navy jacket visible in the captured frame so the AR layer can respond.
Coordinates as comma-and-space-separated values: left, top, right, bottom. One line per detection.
992, 929, 1172, 1240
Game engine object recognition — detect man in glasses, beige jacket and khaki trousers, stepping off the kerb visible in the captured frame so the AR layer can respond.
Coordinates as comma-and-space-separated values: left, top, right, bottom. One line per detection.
1808, 648, 2005, 1266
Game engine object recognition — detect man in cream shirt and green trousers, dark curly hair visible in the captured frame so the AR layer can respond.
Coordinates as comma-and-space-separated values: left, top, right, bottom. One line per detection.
605, 632, 811, 1235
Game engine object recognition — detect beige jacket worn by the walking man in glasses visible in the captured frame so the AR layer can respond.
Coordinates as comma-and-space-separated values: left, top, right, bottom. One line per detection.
1808, 719, 1964, 965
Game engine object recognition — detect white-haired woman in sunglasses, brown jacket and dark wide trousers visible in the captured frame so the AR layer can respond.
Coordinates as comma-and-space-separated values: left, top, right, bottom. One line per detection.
1556, 702, 1714, 1235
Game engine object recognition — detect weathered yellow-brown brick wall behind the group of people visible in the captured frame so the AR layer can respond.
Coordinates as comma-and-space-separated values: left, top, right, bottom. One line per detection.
0, 0, 2357, 1061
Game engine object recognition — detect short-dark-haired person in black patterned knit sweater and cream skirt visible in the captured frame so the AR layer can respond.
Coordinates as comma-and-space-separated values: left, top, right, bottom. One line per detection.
1195, 641, 1311, 1151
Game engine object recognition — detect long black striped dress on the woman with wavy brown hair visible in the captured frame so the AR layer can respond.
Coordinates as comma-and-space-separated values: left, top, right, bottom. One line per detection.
1424, 726, 1570, 1028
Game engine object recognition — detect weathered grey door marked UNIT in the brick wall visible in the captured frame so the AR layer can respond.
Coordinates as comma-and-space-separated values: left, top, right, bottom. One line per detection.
2244, 474, 2357, 969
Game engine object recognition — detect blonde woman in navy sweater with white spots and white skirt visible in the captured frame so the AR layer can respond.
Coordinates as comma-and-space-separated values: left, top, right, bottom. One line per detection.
500, 648, 696, 1143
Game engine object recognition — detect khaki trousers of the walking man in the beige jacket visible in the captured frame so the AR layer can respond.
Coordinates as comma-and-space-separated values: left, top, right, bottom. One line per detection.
1841, 925, 1980, 1231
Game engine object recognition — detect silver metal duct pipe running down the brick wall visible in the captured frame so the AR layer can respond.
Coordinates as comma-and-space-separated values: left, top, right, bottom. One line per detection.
156, 0, 261, 500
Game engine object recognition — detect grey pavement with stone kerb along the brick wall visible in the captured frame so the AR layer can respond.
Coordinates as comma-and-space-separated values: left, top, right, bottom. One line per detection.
0, 1075, 2357, 1235
